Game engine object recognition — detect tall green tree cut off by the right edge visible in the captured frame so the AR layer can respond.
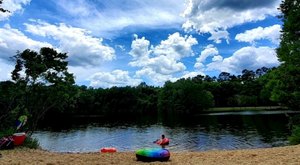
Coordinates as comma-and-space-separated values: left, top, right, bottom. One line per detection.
271, 0, 300, 110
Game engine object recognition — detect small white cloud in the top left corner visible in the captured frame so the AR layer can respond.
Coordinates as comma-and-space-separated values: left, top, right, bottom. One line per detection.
0, 0, 31, 21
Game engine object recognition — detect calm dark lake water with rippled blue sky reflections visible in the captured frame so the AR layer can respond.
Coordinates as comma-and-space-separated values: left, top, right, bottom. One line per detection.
33, 111, 294, 152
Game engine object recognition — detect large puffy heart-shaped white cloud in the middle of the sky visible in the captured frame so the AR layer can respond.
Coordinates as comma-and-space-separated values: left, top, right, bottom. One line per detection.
129, 32, 198, 83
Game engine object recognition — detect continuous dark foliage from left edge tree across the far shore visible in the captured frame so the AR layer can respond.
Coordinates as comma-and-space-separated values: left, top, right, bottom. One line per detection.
0, 63, 277, 130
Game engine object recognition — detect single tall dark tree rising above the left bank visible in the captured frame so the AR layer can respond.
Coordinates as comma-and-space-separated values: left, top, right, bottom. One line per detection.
11, 48, 74, 131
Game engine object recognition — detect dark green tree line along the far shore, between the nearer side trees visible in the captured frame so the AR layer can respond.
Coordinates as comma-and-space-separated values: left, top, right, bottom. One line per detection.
48, 67, 278, 116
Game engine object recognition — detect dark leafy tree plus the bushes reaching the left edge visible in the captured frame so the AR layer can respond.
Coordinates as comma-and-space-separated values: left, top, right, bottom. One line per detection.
0, 48, 76, 135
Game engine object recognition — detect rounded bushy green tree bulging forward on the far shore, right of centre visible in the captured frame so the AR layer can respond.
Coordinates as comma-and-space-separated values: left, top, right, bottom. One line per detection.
158, 79, 214, 114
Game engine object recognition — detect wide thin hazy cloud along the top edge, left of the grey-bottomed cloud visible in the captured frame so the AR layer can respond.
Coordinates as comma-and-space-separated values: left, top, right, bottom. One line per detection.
53, 0, 184, 36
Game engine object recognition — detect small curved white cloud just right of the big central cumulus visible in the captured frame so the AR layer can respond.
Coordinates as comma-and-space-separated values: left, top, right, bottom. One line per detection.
194, 45, 220, 69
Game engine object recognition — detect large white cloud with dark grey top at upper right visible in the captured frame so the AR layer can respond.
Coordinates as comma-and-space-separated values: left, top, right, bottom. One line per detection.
182, 0, 281, 42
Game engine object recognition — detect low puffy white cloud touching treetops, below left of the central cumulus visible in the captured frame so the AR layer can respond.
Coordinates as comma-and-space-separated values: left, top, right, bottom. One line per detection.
90, 70, 142, 88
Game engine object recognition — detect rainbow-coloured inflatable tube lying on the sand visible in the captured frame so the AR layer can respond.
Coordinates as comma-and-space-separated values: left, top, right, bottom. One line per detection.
135, 148, 170, 162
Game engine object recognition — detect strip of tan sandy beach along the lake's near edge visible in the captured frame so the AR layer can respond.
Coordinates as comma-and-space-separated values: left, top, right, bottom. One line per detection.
0, 145, 300, 165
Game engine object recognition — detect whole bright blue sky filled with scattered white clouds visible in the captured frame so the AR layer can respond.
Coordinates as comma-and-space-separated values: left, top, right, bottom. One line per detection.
0, 0, 282, 88
